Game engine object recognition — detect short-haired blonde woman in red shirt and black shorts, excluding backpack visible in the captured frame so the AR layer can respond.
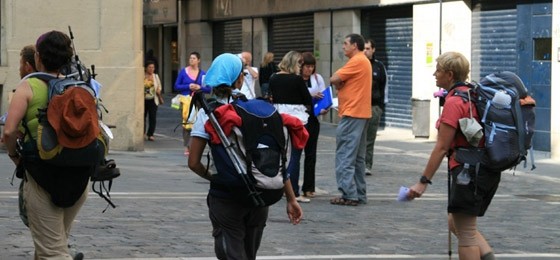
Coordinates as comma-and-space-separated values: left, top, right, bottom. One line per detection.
408, 52, 501, 260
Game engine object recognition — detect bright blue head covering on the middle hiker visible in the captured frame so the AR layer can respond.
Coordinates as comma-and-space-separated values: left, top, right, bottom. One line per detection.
204, 53, 243, 88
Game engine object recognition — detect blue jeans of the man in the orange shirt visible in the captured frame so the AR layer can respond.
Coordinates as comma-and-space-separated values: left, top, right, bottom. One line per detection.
335, 116, 368, 203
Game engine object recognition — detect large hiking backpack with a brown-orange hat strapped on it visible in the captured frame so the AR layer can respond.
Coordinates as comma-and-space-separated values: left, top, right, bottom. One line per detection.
23, 72, 108, 167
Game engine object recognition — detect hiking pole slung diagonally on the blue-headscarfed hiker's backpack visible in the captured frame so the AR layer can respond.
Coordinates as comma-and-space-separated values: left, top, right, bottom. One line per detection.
193, 92, 265, 207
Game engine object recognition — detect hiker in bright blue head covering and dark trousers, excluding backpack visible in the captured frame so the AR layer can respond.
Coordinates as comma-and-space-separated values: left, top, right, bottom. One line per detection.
189, 53, 303, 260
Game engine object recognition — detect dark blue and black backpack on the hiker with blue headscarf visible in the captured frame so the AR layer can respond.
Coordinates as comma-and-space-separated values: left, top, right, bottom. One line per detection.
206, 99, 289, 207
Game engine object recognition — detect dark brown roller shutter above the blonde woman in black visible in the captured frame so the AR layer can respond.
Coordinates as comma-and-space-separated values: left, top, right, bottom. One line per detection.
268, 14, 315, 62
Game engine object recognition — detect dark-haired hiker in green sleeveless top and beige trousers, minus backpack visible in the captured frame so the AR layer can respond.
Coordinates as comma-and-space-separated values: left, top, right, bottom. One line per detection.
4, 31, 91, 259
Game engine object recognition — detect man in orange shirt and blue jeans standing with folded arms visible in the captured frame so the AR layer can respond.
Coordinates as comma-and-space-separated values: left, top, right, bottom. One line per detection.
330, 34, 372, 206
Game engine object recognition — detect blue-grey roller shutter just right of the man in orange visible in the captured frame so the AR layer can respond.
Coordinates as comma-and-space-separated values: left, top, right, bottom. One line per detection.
362, 6, 412, 128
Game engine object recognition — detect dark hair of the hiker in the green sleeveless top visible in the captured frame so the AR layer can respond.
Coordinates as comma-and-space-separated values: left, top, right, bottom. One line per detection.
35, 31, 73, 72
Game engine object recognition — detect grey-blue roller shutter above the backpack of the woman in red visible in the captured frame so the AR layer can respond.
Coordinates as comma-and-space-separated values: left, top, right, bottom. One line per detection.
471, 1, 517, 81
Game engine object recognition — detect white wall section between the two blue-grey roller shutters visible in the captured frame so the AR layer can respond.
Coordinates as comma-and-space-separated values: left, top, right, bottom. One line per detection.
412, 1, 471, 139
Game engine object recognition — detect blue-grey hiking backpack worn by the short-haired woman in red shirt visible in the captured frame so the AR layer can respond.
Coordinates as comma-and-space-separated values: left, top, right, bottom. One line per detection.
455, 71, 535, 171
